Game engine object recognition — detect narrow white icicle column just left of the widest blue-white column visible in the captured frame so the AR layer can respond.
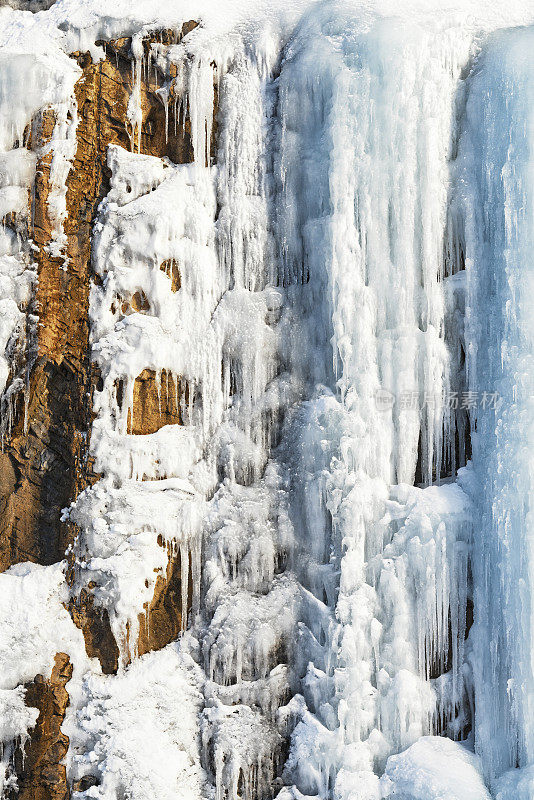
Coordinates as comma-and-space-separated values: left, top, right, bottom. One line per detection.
194, 45, 306, 800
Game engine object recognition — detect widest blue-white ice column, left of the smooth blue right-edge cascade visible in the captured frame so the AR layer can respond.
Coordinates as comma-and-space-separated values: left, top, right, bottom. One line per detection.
278, 6, 476, 798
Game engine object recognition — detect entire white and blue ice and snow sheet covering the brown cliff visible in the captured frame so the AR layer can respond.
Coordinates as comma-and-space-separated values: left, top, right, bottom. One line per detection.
0, 0, 534, 800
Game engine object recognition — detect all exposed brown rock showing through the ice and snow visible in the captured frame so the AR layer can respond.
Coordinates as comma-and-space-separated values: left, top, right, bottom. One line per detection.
0, 22, 214, 800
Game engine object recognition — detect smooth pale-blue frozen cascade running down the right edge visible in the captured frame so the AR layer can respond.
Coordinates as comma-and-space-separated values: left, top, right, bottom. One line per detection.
459, 29, 534, 798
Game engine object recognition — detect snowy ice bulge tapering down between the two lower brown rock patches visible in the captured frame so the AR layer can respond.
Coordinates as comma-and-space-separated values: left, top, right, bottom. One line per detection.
69, 478, 202, 660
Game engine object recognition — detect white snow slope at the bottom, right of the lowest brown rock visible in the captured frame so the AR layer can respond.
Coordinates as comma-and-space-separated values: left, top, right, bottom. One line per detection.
65, 645, 205, 800
